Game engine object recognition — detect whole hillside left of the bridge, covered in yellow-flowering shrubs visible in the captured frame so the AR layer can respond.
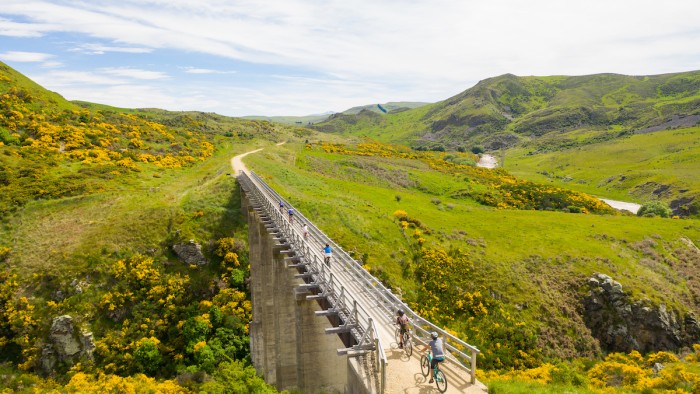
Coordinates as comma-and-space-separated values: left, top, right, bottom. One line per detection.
0, 60, 312, 393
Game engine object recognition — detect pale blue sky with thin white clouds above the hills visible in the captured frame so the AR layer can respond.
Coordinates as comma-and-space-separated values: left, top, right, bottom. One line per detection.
0, 0, 700, 116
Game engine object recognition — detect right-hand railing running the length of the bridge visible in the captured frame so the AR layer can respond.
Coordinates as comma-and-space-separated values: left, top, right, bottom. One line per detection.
241, 171, 480, 384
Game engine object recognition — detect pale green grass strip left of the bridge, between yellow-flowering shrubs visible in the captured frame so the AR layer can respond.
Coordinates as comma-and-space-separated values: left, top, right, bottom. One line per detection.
0, 140, 256, 273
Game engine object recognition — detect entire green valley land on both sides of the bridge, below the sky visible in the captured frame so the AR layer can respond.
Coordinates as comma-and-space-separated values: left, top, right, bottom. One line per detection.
0, 60, 700, 393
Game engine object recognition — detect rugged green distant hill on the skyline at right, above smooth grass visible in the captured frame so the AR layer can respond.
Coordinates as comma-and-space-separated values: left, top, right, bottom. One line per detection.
315, 71, 700, 150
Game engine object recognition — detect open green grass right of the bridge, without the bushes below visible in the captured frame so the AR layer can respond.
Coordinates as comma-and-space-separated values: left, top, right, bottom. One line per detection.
246, 142, 700, 303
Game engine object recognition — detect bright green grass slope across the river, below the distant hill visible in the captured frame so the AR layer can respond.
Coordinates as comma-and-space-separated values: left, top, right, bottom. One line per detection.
504, 127, 700, 203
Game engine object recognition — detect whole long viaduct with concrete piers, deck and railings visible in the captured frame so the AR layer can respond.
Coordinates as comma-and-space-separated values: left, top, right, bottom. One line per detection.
238, 170, 486, 394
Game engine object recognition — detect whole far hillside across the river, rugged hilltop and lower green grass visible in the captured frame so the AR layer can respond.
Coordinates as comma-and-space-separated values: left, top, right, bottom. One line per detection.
314, 71, 700, 216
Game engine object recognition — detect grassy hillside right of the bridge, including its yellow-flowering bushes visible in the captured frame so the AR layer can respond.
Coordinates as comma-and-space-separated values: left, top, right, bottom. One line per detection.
247, 140, 700, 392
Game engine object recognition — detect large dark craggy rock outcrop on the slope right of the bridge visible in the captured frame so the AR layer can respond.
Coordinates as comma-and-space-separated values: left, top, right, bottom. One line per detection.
583, 274, 700, 352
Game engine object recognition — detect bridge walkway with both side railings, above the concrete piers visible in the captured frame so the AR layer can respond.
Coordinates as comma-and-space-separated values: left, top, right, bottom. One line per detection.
239, 165, 486, 393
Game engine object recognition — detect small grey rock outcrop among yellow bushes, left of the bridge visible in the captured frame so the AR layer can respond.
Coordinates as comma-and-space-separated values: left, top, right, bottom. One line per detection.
40, 315, 95, 375
